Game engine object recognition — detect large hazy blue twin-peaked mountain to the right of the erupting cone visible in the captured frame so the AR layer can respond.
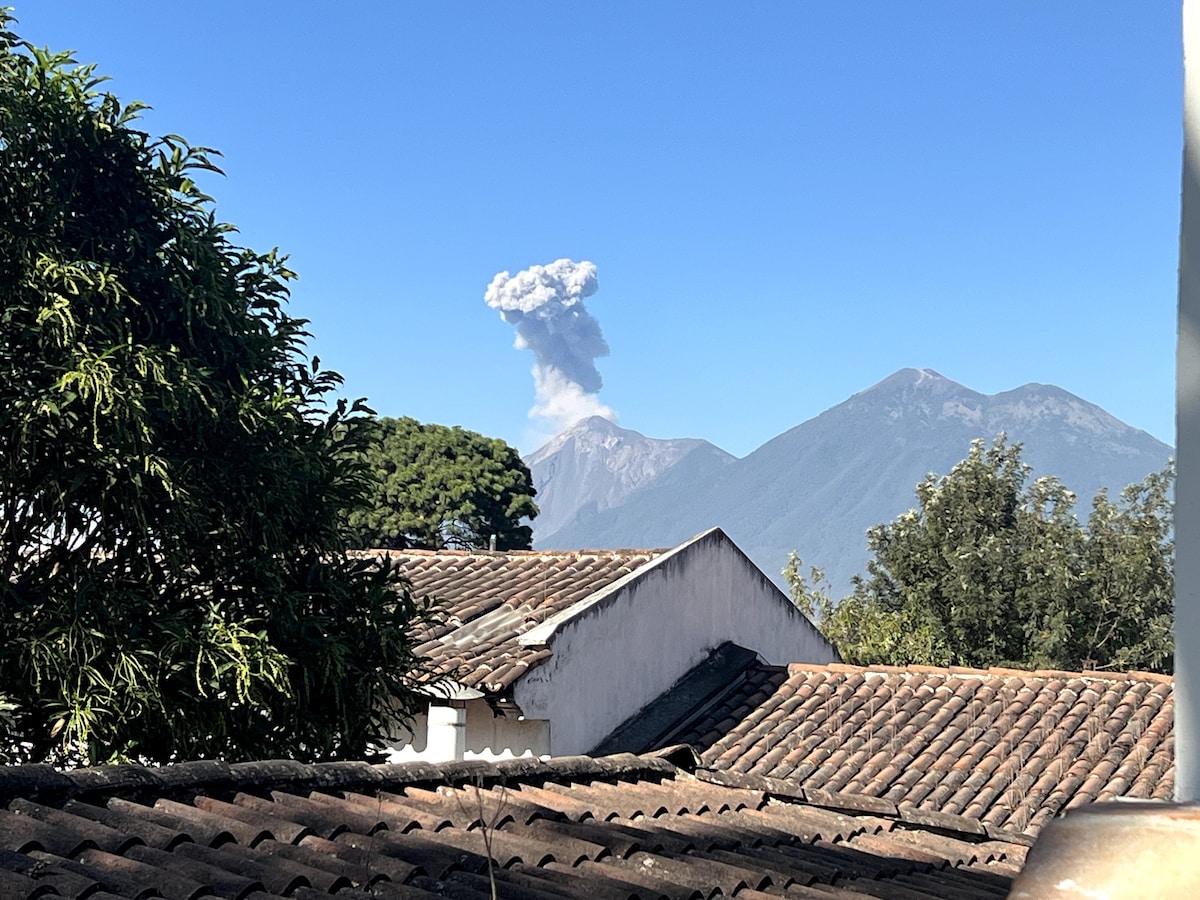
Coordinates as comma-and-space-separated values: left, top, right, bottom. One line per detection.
530, 368, 1172, 594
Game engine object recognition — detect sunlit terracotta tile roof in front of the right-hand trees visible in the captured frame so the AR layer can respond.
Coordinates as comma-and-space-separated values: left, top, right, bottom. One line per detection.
696, 664, 1175, 834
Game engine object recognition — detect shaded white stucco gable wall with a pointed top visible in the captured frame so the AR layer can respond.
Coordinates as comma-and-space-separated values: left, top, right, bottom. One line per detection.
514, 528, 836, 756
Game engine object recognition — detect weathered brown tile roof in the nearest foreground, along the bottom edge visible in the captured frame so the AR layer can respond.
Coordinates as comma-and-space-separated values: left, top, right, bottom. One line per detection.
0, 755, 1031, 900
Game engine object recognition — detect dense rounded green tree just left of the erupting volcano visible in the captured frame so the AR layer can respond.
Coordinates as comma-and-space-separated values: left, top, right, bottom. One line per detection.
348, 418, 538, 550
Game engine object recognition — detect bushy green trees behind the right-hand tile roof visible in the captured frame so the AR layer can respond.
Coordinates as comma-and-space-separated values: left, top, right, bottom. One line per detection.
784, 434, 1174, 671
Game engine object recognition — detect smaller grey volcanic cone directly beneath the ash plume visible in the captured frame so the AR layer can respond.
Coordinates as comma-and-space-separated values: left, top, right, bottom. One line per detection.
524, 416, 734, 546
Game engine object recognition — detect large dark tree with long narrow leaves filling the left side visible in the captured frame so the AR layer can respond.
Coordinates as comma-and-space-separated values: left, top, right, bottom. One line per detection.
0, 12, 424, 762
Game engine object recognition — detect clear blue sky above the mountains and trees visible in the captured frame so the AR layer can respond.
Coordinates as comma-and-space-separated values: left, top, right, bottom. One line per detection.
13, 0, 1182, 455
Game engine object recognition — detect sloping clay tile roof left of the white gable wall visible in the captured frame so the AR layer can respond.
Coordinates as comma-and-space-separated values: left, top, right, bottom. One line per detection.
360, 550, 665, 691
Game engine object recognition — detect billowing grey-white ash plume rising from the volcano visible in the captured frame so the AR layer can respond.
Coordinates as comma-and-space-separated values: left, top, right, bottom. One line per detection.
484, 259, 616, 431
